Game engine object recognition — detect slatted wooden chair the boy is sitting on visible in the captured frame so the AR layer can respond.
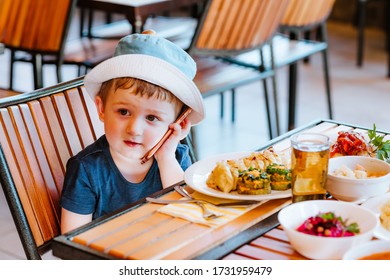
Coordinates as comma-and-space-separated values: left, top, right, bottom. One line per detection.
0, 77, 196, 259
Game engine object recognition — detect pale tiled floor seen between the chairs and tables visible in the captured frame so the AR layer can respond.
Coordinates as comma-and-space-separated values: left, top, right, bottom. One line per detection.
0, 14, 390, 259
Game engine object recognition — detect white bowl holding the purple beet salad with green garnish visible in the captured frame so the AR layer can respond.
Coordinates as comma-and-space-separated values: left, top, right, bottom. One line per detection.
278, 200, 378, 260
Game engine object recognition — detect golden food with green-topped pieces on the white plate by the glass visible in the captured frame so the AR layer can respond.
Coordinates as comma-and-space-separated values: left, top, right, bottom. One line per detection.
206, 148, 291, 194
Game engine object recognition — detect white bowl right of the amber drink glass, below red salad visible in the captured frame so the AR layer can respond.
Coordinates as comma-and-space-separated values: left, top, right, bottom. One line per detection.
326, 156, 390, 202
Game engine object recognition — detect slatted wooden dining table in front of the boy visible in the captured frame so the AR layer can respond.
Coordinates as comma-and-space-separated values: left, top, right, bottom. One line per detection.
52, 120, 386, 260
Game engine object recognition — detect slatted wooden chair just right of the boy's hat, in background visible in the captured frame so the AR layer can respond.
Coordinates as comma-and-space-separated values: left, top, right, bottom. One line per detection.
188, 0, 289, 138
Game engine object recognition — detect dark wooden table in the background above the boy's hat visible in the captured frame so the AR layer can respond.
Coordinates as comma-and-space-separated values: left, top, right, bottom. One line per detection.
77, 0, 203, 33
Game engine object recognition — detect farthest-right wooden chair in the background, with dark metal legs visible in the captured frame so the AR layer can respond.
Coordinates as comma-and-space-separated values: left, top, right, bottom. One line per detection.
227, 0, 335, 130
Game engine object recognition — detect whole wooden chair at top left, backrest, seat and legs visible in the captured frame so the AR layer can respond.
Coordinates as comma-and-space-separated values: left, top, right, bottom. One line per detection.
0, 0, 117, 89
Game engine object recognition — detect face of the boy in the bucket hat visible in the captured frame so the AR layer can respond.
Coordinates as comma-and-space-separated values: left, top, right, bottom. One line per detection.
96, 88, 178, 160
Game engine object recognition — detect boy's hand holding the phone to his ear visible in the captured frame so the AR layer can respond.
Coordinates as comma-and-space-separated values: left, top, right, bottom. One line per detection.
154, 119, 191, 162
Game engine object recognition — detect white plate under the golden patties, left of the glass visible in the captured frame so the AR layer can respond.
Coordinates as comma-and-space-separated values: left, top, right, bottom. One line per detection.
184, 152, 291, 201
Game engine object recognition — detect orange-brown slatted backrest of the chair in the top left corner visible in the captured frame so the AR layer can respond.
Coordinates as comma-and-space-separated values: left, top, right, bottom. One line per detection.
0, 0, 76, 52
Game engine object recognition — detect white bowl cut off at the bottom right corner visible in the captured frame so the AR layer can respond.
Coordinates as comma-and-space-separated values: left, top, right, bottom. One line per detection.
343, 240, 390, 260
